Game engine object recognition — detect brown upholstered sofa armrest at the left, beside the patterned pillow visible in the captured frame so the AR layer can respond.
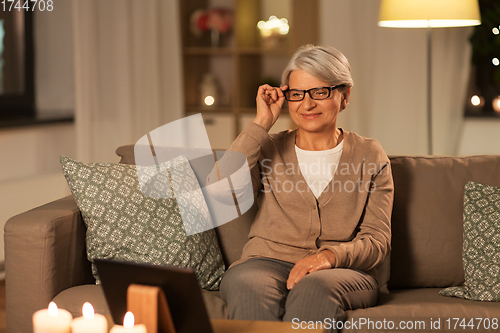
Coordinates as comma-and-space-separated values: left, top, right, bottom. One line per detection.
4, 196, 94, 333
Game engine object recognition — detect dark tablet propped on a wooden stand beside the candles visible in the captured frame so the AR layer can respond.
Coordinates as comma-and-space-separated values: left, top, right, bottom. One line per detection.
94, 259, 212, 333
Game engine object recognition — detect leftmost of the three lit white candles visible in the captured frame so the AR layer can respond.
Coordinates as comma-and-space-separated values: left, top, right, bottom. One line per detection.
33, 302, 73, 333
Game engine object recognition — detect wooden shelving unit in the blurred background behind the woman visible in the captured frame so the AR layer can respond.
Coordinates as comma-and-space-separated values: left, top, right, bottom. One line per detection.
179, 0, 320, 147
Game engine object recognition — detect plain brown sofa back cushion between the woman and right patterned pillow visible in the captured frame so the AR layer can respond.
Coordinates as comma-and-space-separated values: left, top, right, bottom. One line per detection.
389, 156, 500, 289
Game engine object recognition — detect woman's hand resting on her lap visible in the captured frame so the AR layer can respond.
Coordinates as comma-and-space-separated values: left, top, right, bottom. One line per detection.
286, 250, 335, 290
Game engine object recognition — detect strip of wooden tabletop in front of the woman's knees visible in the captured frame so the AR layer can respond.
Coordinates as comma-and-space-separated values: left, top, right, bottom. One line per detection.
210, 319, 327, 333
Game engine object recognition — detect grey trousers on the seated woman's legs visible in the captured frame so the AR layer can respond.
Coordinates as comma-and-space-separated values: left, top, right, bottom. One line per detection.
220, 258, 379, 322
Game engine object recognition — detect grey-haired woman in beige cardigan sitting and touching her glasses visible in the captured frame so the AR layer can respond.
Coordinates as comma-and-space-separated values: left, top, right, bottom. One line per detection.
220, 45, 393, 323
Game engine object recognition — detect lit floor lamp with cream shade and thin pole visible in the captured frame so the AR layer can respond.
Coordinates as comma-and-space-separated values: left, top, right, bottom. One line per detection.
378, 0, 481, 155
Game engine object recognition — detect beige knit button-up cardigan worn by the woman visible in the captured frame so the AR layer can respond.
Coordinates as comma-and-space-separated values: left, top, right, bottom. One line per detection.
219, 123, 394, 283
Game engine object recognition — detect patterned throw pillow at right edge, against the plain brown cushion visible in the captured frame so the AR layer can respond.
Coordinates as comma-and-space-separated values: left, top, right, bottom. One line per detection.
440, 182, 500, 301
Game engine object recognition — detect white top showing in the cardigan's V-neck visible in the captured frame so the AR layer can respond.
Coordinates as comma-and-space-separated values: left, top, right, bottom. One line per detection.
295, 140, 344, 199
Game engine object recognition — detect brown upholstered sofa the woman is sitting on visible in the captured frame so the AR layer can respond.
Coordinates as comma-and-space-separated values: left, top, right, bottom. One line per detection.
5, 146, 500, 333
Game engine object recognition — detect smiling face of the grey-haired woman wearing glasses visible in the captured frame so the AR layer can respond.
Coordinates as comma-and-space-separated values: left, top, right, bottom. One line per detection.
288, 70, 351, 135
